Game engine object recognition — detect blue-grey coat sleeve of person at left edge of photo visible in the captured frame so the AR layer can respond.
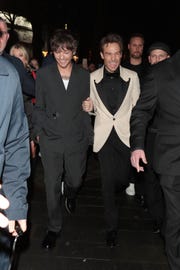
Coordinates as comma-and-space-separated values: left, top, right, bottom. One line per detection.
0, 73, 30, 220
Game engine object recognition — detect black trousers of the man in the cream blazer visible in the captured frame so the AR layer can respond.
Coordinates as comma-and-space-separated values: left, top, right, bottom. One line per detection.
98, 130, 130, 231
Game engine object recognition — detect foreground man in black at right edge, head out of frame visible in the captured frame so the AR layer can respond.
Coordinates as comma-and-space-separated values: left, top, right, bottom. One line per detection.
130, 50, 180, 270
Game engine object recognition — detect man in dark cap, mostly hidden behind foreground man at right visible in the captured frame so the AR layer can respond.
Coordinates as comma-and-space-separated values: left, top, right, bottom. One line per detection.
141, 41, 171, 235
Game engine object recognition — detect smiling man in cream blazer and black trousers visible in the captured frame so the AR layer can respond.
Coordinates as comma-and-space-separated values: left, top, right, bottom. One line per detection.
83, 33, 140, 247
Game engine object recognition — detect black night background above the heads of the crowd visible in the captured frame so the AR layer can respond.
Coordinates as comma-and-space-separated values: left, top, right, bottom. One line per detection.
0, 0, 180, 62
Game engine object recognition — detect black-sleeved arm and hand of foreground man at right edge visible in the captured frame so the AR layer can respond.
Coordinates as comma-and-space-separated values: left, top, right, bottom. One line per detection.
130, 69, 157, 172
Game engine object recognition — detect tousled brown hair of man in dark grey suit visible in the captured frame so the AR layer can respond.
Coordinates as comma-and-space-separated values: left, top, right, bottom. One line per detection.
50, 29, 78, 52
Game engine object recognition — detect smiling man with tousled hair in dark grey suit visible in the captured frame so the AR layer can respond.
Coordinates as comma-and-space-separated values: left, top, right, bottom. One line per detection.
33, 29, 92, 249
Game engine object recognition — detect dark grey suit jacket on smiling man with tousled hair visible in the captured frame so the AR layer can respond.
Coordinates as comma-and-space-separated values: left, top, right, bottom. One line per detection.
33, 61, 93, 151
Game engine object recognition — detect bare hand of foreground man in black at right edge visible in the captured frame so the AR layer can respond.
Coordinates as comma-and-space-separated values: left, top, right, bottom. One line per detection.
131, 149, 147, 172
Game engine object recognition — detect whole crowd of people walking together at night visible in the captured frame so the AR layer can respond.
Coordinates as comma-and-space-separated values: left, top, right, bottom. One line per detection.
0, 14, 180, 270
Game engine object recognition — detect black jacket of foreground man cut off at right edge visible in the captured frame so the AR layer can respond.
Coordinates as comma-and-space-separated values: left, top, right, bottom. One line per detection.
130, 50, 180, 175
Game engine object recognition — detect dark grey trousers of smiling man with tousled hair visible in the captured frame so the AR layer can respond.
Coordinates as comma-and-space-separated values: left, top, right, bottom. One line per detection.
40, 144, 87, 232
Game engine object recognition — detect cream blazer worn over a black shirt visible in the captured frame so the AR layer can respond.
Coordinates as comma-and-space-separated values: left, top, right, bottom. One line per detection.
90, 66, 140, 152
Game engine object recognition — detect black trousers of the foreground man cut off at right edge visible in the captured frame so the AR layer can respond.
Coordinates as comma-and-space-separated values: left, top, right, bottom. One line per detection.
160, 175, 180, 270
